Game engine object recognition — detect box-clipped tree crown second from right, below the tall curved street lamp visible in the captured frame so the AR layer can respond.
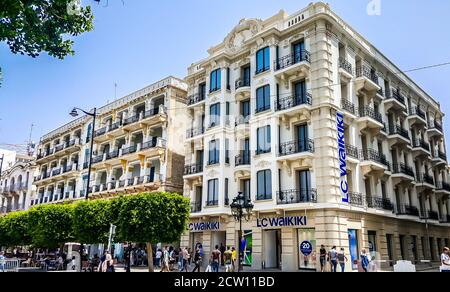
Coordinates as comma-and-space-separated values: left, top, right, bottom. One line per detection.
73, 200, 113, 244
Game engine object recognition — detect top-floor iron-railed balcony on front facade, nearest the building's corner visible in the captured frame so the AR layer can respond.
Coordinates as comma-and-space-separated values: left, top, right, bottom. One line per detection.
274, 50, 311, 81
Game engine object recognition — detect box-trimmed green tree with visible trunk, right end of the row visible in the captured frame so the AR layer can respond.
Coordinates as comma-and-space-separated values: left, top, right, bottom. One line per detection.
116, 193, 190, 272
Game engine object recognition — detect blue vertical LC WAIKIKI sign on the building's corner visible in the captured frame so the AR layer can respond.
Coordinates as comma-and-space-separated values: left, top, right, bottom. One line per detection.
336, 112, 349, 203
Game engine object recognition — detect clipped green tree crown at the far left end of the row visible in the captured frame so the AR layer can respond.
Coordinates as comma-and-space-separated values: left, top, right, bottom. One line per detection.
0, 211, 31, 247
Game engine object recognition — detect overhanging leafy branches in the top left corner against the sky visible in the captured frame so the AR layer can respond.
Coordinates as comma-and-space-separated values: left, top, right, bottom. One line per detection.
0, 0, 94, 85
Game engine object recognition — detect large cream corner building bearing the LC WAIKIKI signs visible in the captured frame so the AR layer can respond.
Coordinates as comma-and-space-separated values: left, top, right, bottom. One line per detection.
181, 3, 450, 271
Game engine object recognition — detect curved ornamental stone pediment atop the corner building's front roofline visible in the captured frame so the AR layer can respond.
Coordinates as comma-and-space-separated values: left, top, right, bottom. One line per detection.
224, 18, 262, 53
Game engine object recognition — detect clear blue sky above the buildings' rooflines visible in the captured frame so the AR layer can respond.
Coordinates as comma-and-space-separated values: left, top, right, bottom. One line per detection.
0, 0, 450, 151
